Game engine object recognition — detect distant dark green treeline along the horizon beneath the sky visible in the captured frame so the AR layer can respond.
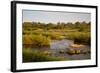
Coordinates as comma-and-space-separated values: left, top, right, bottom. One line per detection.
23, 22, 91, 31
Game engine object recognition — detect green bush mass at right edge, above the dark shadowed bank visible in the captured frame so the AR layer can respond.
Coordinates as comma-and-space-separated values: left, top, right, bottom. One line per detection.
66, 32, 91, 45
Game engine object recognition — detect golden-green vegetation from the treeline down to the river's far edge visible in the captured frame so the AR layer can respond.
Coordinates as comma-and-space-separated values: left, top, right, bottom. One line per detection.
23, 22, 91, 47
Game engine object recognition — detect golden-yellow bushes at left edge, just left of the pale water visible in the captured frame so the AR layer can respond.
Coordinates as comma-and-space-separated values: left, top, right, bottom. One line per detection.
23, 34, 50, 47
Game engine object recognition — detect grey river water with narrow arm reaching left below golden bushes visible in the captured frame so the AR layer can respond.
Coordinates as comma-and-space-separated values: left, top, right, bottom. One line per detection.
30, 39, 91, 60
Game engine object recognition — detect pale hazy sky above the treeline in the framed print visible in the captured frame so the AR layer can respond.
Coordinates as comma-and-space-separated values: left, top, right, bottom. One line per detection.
23, 10, 91, 23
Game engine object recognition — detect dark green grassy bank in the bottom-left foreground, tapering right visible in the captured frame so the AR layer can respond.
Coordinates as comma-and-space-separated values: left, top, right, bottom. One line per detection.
23, 48, 65, 62
